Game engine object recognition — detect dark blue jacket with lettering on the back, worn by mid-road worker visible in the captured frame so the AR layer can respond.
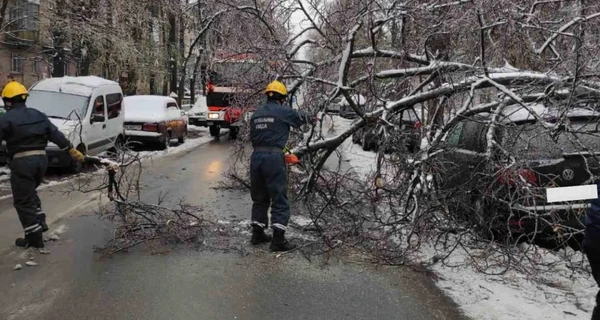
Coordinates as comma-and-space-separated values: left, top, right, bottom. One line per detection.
250, 101, 310, 150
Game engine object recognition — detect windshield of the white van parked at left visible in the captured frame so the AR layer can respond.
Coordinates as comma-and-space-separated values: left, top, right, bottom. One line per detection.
27, 90, 90, 121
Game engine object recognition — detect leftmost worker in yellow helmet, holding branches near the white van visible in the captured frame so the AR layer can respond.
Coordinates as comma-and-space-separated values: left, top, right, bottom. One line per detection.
0, 81, 84, 248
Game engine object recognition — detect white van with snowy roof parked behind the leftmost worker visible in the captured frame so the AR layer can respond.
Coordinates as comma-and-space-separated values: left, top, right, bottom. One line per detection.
27, 76, 124, 172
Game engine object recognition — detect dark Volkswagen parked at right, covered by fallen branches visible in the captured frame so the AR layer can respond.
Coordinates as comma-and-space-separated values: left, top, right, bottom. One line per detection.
439, 105, 600, 248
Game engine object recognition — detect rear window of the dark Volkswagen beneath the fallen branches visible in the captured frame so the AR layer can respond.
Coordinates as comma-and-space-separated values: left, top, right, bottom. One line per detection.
503, 121, 600, 160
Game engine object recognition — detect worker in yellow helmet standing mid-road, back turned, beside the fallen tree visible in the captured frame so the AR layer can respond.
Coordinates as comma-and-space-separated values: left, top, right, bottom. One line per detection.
250, 81, 311, 251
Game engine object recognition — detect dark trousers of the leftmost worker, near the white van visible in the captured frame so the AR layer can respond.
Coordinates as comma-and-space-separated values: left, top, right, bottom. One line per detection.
9, 155, 48, 234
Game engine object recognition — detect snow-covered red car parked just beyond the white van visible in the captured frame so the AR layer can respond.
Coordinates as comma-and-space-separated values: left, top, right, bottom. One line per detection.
124, 95, 188, 150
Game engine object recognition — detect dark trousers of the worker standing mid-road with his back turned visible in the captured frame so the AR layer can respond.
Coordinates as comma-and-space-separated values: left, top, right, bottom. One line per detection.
250, 151, 290, 231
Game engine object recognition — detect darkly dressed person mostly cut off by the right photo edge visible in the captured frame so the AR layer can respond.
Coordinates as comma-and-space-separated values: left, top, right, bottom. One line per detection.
583, 181, 600, 320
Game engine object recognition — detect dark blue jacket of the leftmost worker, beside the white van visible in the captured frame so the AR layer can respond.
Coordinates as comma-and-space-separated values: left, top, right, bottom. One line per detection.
0, 103, 71, 158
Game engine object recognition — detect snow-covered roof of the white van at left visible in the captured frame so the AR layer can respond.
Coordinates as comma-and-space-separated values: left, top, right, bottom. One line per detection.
30, 76, 119, 96
